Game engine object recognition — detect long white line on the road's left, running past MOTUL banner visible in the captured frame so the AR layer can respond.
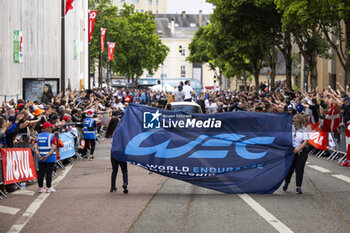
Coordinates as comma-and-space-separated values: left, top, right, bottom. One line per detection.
8, 166, 73, 233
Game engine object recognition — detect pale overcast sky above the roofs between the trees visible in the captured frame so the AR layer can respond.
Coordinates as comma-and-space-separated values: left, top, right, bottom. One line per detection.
168, 0, 213, 14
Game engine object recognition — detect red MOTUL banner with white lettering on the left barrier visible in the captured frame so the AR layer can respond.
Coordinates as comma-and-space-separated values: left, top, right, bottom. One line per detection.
1, 148, 37, 184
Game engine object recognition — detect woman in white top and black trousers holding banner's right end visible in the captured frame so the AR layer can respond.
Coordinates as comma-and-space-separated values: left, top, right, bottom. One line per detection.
283, 114, 309, 194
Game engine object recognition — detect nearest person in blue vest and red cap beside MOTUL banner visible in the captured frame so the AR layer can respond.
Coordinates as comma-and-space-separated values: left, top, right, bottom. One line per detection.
34, 122, 56, 193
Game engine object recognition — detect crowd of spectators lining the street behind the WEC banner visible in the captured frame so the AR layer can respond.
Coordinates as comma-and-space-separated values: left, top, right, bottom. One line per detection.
0, 79, 350, 198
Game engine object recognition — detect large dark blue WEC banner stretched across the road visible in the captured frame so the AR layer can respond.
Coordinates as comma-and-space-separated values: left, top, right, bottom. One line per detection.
112, 105, 294, 193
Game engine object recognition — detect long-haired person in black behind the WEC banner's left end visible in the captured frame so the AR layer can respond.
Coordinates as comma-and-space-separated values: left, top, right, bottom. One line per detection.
105, 117, 128, 193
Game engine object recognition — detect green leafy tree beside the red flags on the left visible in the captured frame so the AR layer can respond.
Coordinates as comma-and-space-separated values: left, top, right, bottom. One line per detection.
90, 0, 169, 85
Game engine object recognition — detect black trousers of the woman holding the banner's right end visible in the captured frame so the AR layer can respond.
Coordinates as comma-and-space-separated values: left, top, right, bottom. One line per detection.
284, 148, 309, 187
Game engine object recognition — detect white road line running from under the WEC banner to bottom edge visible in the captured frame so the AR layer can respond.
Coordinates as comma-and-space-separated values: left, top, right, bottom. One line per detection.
238, 194, 293, 233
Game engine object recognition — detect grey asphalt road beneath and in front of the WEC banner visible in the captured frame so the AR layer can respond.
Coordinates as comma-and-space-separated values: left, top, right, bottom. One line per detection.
0, 144, 350, 233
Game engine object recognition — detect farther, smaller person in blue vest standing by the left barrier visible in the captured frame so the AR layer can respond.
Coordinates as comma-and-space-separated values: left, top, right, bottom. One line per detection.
83, 110, 97, 160
